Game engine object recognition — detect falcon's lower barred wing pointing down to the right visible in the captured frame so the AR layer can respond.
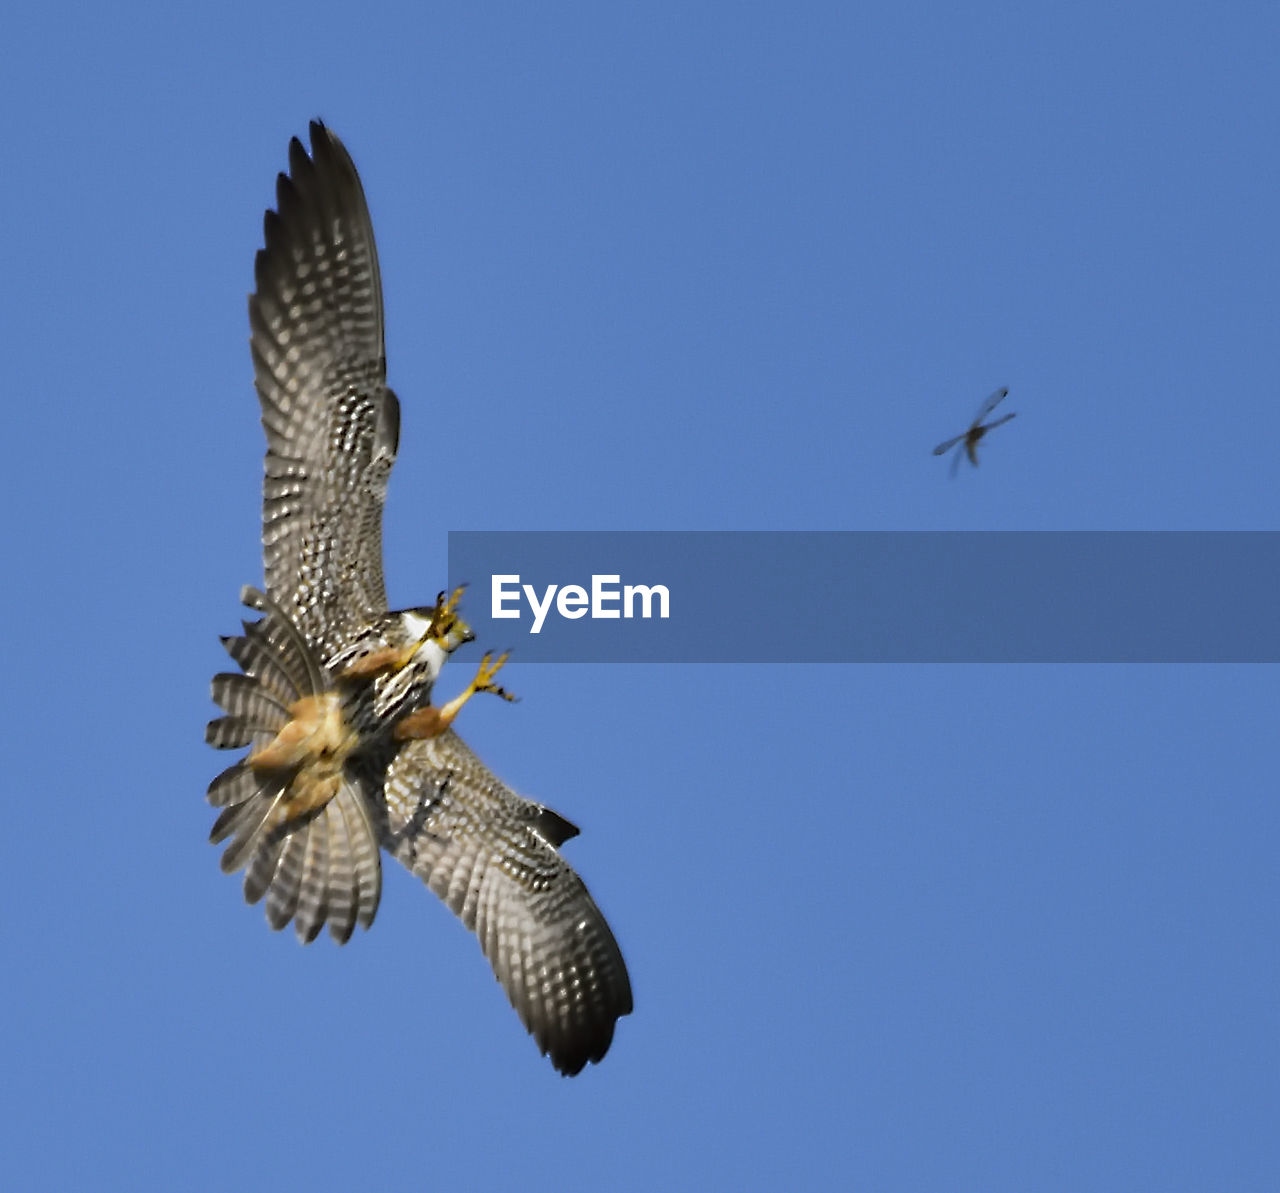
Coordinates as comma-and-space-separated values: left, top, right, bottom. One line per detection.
383, 730, 631, 1074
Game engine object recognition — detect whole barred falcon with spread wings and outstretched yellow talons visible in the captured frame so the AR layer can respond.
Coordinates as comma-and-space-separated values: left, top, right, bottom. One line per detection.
206, 122, 632, 1074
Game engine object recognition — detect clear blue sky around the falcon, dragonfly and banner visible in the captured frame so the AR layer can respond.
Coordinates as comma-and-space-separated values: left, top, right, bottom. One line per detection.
0, 3, 1280, 1193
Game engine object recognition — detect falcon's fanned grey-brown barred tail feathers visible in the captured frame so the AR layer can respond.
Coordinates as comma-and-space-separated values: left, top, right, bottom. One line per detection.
205, 586, 383, 943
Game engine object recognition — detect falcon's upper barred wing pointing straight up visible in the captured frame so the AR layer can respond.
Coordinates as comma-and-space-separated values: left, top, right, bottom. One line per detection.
248, 122, 399, 655
